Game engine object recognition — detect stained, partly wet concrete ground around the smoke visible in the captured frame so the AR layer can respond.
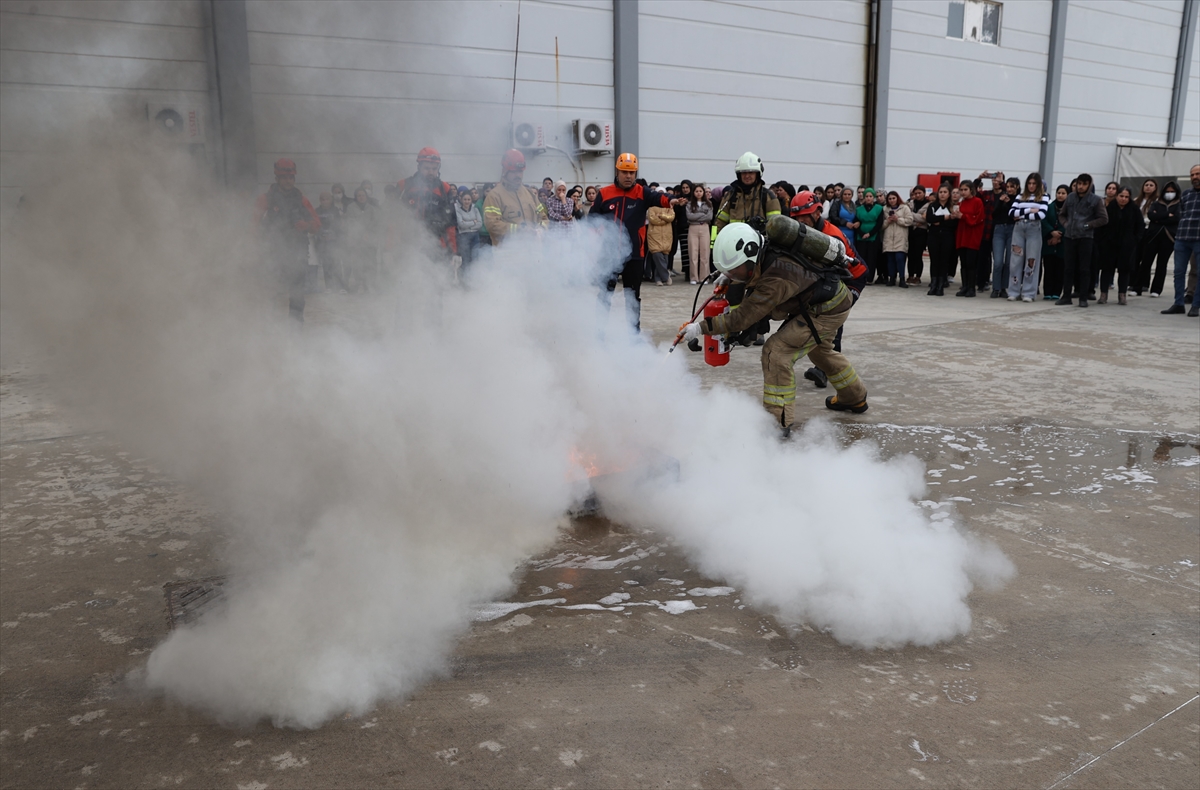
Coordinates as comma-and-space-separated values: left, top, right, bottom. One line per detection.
0, 271, 1200, 790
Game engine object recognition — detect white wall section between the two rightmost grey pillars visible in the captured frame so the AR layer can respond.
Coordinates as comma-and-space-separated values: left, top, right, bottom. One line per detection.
1056, 0, 1196, 185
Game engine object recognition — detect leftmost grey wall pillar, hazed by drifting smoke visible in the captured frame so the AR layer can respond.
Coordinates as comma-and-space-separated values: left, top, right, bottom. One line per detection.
210, 0, 258, 190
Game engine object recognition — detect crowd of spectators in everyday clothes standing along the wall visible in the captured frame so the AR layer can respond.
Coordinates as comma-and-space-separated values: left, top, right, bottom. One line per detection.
260, 158, 1196, 312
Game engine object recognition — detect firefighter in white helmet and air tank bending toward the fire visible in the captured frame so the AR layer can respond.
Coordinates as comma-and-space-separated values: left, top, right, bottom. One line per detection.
683, 216, 866, 436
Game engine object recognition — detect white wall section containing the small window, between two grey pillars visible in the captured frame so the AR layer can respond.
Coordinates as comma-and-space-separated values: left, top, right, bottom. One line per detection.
876, 0, 1051, 194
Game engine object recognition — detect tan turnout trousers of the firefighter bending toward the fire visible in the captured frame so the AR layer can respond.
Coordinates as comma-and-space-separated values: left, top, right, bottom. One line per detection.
762, 286, 866, 426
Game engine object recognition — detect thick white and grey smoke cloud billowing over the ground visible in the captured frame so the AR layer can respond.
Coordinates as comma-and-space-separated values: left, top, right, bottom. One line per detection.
0, 133, 1012, 728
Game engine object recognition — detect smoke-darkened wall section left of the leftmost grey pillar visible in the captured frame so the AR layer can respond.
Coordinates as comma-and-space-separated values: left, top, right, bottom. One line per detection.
0, 0, 212, 216
